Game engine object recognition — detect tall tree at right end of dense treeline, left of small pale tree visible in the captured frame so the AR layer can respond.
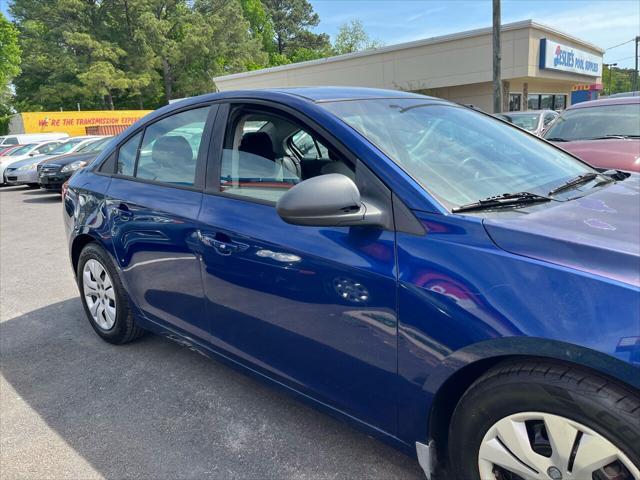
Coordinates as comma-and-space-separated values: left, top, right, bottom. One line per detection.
263, 0, 330, 56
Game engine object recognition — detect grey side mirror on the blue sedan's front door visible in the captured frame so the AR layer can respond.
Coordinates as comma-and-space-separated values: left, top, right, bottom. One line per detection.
276, 173, 384, 227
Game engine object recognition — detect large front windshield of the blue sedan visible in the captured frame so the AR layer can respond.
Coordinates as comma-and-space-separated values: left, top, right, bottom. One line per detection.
321, 99, 594, 208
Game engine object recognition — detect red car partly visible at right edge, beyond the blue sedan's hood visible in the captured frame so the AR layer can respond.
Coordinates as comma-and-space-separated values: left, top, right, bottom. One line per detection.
544, 97, 640, 172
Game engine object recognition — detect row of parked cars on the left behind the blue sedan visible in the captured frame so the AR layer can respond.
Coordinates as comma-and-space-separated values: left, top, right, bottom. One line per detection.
0, 135, 111, 191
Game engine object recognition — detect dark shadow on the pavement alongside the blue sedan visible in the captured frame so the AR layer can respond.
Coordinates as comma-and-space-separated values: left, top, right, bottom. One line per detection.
0, 298, 423, 480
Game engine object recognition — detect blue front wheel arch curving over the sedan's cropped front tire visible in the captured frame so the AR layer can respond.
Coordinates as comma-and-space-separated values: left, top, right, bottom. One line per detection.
424, 337, 640, 463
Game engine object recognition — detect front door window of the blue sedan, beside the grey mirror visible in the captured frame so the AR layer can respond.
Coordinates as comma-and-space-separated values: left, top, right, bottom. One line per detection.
220, 109, 353, 202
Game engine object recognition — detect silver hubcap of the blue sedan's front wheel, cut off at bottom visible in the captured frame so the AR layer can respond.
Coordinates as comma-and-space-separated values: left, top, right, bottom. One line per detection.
478, 412, 640, 480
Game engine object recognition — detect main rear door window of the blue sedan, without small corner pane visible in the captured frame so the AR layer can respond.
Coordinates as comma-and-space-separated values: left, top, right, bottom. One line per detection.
135, 107, 209, 186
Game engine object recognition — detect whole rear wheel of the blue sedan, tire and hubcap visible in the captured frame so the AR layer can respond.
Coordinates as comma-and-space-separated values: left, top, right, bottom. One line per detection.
76, 243, 144, 345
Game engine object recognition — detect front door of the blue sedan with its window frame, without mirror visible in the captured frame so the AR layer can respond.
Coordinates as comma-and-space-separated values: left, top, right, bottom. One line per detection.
199, 105, 397, 432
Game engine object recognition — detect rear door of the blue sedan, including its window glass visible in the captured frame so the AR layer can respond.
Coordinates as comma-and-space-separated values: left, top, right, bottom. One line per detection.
106, 105, 217, 339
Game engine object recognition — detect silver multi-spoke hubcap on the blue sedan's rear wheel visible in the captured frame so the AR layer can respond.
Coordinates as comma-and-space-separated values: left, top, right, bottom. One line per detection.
82, 258, 116, 330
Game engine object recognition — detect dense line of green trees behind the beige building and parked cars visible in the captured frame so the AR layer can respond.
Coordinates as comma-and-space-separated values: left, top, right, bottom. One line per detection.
7, 0, 377, 109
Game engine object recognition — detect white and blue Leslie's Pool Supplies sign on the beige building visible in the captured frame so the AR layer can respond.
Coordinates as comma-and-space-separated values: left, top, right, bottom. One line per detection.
540, 38, 602, 77
